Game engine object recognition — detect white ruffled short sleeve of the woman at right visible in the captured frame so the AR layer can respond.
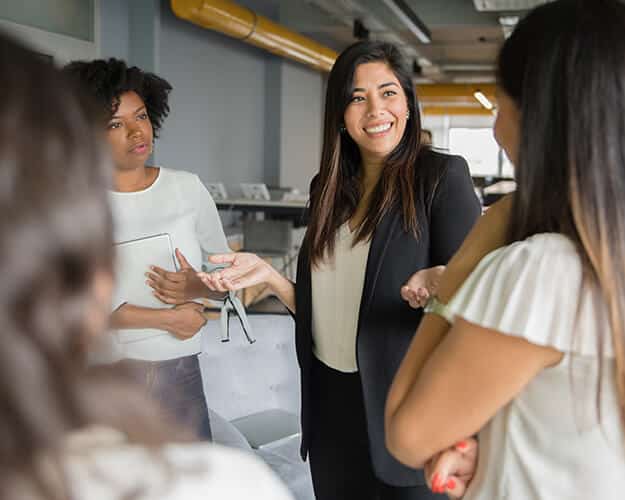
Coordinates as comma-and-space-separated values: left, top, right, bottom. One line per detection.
445, 233, 613, 357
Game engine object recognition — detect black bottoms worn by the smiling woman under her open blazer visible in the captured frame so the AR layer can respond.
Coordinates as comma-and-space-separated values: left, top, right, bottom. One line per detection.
308, 359, 447, 500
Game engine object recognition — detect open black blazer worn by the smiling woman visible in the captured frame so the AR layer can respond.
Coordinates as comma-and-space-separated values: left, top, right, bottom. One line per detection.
295, 149, 480, 486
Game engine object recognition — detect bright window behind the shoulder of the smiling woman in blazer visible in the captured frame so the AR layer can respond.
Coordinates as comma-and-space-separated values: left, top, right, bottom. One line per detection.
449, 127, 513, 177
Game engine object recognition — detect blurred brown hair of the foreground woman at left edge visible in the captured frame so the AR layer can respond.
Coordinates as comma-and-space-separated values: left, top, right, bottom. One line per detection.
0, 34, 177, 500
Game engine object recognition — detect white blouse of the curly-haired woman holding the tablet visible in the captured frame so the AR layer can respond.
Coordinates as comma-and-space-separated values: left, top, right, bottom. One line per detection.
100, 168, 230, 362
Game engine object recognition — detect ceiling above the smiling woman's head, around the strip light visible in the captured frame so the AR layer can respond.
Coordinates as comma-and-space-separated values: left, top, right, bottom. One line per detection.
264, 0, 548, 83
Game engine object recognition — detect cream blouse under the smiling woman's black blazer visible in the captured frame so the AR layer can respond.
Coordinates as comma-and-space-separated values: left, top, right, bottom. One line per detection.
310, 223, 371, 373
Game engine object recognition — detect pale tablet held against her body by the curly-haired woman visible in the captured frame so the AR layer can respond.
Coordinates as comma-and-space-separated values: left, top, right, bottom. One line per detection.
115, 233, 177, 307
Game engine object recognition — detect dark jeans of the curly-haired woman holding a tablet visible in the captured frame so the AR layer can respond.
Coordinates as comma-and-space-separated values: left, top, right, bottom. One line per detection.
124, 355, 211, 441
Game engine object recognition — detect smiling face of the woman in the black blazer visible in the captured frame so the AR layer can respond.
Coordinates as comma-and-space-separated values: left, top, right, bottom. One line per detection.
343, 62, 408, 162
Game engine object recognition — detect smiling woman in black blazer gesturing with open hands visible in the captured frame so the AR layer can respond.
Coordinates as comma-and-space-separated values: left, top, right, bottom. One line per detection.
201, 42, 480, 500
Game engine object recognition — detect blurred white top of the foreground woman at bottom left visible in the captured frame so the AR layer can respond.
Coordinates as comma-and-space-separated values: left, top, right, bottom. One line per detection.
65, 428, 293, 500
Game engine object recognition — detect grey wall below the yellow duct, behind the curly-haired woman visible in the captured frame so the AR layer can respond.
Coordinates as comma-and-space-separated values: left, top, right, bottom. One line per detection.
12, 0, 324, 196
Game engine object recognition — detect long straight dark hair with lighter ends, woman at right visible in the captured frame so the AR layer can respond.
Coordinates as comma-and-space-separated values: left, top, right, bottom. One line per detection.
498, 0, 625, 417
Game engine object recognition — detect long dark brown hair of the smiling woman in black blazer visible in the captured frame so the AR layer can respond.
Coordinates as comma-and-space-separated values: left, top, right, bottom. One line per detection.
306, 42, 432, 263
